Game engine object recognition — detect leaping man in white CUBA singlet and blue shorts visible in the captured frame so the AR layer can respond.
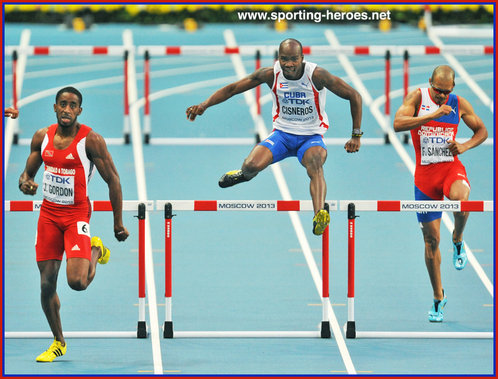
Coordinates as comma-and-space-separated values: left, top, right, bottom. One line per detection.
186, 39, 363, 235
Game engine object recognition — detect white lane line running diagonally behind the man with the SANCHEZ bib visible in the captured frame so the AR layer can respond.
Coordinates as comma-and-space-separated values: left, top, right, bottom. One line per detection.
325, 30, 494, 297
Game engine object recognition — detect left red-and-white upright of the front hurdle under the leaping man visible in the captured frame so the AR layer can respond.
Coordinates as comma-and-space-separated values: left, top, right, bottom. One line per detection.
163, 203, 173, 338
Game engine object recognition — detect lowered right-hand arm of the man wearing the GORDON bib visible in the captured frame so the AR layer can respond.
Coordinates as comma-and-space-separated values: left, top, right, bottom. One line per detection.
86, 130, 129, 241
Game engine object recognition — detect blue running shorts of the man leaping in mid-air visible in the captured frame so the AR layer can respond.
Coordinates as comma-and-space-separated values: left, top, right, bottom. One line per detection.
260, 129, 327, 163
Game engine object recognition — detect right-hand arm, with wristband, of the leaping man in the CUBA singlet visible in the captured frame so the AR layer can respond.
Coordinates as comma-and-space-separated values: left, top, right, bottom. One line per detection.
313, 67, 362, 153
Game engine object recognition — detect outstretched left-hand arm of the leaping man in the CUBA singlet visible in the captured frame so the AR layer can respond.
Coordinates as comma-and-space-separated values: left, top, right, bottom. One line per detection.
186, 67, 273, 121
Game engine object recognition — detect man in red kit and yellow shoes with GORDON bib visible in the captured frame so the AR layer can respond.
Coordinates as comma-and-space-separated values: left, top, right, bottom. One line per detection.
19, 87, 129, 362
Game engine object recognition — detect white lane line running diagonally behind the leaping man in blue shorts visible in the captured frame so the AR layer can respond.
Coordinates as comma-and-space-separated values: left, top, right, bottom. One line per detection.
223, 30, 356, 374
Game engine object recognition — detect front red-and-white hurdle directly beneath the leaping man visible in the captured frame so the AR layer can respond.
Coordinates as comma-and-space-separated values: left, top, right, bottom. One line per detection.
156, 200, 337, 338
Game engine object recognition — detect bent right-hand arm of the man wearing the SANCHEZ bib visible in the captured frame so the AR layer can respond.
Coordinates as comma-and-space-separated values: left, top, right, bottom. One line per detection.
448, 96, 488, 155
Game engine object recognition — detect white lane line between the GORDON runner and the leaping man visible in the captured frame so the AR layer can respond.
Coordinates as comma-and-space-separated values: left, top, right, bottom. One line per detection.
123, 29, 163, 375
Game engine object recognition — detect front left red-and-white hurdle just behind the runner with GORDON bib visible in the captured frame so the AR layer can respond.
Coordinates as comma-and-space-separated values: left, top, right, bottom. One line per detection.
4, 200, 154, 338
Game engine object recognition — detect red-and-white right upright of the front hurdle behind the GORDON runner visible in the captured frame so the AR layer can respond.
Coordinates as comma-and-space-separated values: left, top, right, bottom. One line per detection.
137, 203, 147, 338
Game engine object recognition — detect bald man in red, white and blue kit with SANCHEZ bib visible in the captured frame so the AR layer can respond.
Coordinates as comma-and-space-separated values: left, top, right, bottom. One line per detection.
394, 66, 488, 322
